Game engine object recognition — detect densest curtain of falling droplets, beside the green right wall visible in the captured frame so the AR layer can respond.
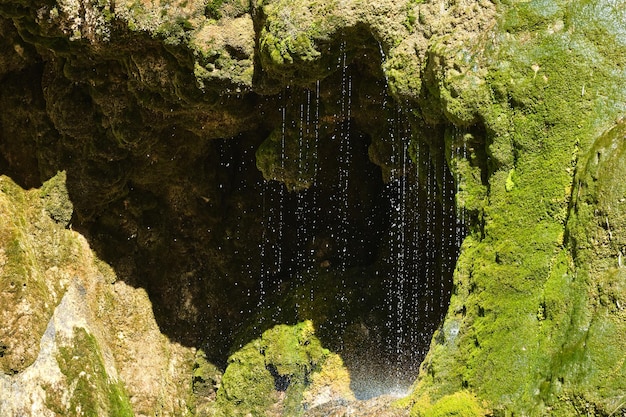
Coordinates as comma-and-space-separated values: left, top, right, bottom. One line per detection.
376, 99, 465, 392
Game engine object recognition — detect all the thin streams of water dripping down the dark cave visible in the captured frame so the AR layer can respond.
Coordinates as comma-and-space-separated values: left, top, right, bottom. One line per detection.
252, 56, 467, 392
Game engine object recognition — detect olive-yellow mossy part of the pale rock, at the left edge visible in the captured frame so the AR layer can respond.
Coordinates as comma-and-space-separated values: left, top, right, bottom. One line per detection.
0, 177, 75, 374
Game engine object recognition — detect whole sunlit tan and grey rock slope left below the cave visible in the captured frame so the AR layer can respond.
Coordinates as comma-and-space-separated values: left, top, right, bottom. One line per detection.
0, 173, 194, 416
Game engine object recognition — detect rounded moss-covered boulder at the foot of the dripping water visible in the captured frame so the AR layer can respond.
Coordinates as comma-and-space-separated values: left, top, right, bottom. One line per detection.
216, 321, 349, 416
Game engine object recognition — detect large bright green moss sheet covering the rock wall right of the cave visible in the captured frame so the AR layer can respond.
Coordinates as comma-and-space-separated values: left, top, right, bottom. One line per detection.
408, 1, 624, 415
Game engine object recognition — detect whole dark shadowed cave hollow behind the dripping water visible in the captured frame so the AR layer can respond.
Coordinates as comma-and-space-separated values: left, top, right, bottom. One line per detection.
2, 30, 465, 398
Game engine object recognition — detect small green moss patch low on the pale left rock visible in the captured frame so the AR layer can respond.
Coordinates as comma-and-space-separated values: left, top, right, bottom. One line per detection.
56, 328, 134, 417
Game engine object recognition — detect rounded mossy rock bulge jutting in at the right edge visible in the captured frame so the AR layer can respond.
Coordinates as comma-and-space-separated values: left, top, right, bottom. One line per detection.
545, 122, 626, 415
